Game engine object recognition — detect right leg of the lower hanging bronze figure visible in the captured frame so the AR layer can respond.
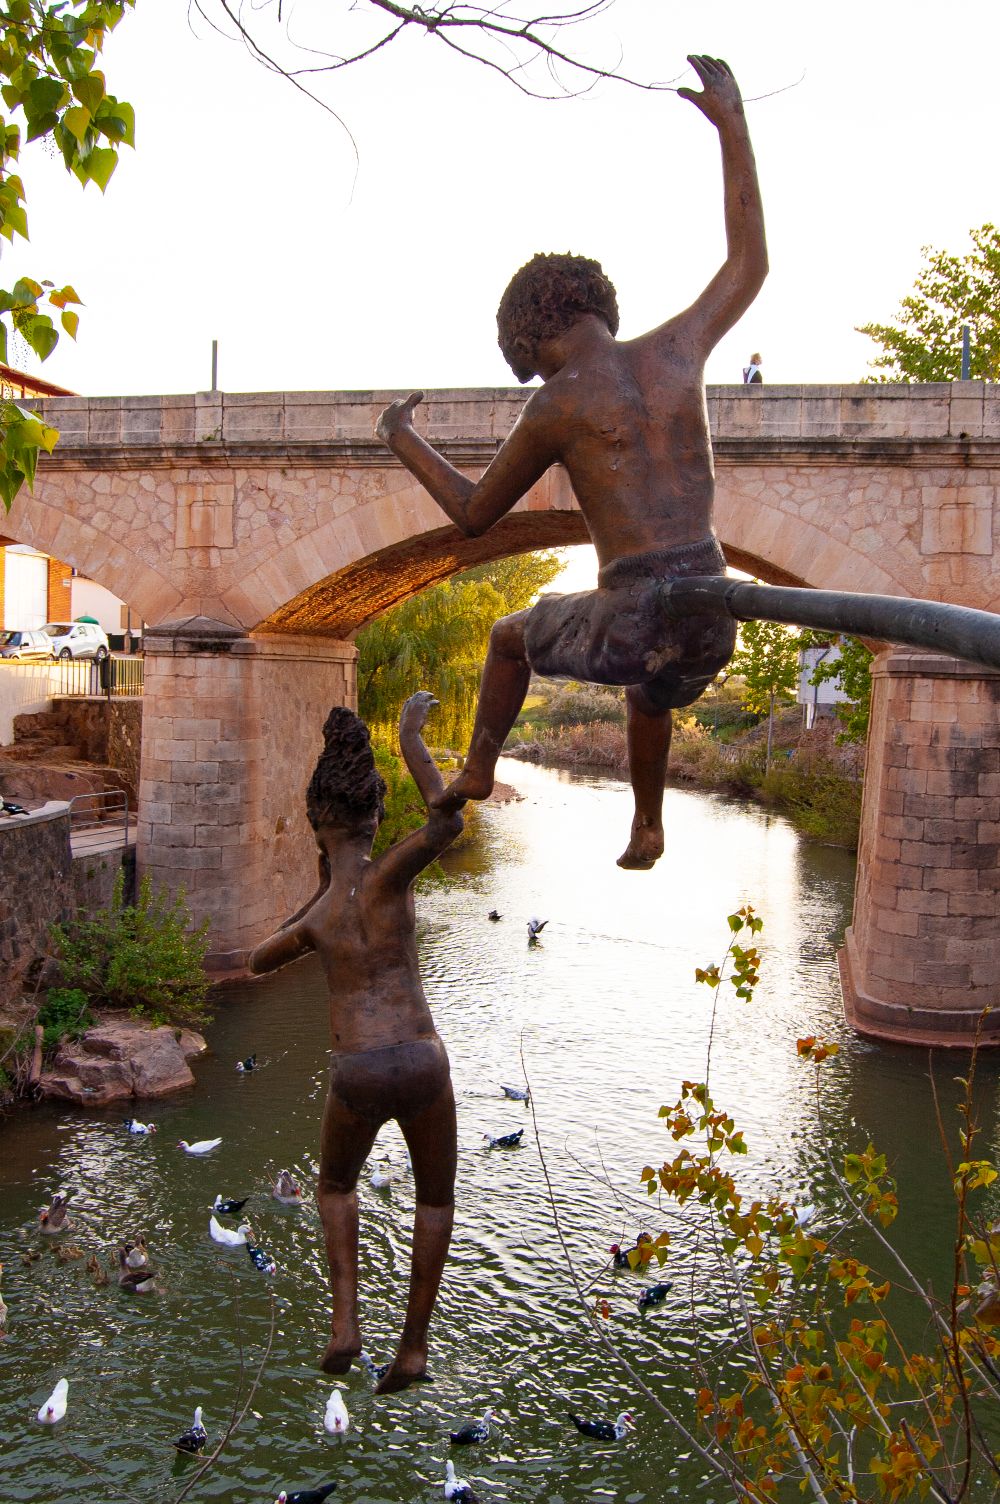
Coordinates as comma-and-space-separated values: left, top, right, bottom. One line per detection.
377, 1081, 457, 1394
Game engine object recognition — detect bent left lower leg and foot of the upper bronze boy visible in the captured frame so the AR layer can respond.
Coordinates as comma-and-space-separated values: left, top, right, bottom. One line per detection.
433, 611, 531, 811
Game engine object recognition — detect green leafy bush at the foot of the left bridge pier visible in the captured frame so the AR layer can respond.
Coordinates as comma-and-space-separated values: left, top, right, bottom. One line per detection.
51, 872, 209, 1026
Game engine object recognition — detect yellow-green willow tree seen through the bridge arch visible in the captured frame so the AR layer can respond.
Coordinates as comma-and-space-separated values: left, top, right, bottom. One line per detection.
358, 552, 562, 746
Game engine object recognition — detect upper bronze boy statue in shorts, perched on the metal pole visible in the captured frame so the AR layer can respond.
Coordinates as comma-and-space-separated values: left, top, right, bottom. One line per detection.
377, 57, 767, 868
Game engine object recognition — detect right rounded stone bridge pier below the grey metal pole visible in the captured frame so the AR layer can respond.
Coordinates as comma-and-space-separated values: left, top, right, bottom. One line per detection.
839, 650, 1000, 1047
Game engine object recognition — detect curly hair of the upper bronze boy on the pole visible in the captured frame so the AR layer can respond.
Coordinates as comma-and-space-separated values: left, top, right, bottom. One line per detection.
496, 254, 618, 359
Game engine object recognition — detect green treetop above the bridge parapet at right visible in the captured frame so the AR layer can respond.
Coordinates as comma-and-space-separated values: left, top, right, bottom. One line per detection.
857, 224, 1000, 381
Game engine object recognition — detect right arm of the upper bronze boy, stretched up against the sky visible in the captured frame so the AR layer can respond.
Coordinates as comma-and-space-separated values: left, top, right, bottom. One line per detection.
672, 57, 767, 355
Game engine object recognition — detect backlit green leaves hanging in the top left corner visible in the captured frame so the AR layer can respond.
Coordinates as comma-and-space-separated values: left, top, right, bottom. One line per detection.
0, 0, 135, 510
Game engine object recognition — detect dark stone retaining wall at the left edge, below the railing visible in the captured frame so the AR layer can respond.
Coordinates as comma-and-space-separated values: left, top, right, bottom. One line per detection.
0, 803, 74, 1008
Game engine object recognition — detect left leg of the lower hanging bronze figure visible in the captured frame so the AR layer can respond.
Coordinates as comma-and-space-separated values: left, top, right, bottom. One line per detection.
316, 1092, 377, 1373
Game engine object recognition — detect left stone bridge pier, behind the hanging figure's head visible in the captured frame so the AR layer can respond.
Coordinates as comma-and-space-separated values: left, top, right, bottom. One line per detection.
137, 617, 356, 975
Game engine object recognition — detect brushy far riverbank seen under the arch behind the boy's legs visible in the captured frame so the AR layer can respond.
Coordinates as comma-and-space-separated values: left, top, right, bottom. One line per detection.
504, 710, 865, 851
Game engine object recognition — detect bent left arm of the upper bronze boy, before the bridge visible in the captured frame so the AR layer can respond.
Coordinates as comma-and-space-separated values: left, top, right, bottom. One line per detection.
374, 391, 558, 538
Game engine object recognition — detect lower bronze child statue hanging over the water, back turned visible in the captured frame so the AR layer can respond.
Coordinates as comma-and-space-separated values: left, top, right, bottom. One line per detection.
248, 690, 463, 1394
